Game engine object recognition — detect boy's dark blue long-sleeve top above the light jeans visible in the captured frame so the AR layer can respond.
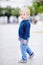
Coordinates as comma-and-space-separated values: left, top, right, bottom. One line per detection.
18, 20, 30, 40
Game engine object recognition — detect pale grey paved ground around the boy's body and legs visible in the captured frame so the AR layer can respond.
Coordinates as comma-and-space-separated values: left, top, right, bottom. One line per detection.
0, 23, 43, 65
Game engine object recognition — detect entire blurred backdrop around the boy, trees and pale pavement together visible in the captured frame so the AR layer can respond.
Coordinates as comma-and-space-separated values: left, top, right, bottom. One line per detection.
0, 0, 43, 65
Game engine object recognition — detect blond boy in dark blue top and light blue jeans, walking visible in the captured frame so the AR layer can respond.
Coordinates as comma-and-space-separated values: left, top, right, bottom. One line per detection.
18, 7, 33, 63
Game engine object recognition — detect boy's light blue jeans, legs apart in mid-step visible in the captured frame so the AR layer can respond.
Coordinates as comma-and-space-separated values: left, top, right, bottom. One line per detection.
20, 38, 33, 60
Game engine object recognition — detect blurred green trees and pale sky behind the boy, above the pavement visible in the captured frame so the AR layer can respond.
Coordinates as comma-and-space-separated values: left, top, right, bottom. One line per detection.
0, 0, 43, 24
